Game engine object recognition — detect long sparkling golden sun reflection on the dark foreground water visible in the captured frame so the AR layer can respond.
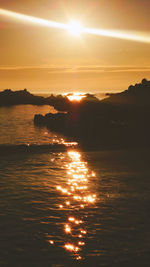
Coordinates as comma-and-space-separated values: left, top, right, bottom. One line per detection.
56, 151, 96, 260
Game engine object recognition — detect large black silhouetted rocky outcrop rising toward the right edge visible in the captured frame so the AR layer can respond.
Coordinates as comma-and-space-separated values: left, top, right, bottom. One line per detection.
34, 79, 150, 149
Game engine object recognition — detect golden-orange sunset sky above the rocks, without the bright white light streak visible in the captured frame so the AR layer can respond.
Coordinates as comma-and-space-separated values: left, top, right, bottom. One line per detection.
0, 0, 150, 93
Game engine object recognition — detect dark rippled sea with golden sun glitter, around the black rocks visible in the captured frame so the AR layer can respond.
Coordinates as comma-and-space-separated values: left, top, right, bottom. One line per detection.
0, 105, 150, 267
